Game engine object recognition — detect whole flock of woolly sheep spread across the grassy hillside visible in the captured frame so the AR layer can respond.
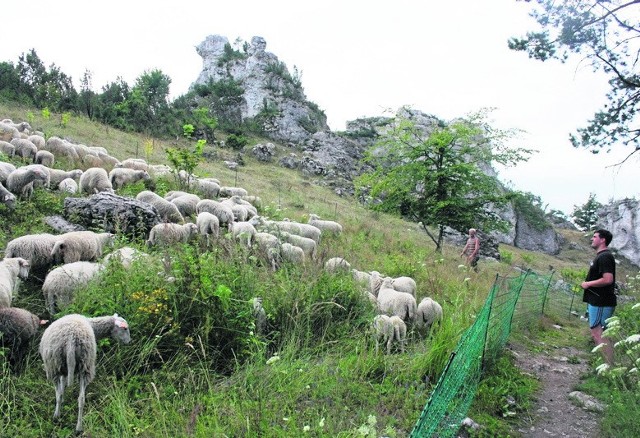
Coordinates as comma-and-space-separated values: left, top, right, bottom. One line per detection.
0, 119, 442, 431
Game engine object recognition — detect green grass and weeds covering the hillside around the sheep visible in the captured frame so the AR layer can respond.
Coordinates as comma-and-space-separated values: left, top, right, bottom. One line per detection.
0, 103, 633, 437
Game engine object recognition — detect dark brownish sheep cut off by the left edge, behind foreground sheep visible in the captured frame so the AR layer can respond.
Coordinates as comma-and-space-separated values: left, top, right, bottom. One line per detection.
0, 307, 48, 371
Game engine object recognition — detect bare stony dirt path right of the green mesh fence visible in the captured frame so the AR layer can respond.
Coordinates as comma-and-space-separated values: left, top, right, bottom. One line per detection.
510, 345, 599, 438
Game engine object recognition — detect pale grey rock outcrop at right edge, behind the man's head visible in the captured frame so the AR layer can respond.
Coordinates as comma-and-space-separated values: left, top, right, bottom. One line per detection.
597, 198, 640, 266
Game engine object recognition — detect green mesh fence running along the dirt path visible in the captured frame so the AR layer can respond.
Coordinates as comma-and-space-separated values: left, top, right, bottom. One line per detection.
411, 272, 556, 438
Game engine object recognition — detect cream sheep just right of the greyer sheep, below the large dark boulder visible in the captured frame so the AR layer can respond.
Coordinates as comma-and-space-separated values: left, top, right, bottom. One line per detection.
51, 231, 115, 263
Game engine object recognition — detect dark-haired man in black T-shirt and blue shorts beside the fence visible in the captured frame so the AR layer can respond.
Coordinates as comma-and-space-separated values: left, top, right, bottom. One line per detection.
580, 230, 617, 365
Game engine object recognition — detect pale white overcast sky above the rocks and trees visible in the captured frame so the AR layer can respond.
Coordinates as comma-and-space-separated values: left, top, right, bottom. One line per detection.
0, 0, 640, 214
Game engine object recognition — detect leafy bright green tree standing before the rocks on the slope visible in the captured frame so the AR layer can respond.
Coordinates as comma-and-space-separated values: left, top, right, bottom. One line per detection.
355, 108, 531, 251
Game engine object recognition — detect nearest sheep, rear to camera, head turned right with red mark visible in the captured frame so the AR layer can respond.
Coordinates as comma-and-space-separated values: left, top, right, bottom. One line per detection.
38, 314, 131, 433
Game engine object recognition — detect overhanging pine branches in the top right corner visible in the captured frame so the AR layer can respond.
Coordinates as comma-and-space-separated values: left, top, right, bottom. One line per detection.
509, 0, 640, 162
